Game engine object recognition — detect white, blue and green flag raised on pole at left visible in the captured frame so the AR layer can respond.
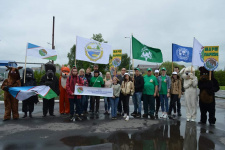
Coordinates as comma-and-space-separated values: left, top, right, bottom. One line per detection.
27, 43, 57, 61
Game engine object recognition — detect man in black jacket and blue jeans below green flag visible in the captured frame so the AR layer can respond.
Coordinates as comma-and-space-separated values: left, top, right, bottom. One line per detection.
131, 68, 144, 118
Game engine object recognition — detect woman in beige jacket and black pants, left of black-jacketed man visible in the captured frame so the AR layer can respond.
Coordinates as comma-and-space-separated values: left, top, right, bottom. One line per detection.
121, 73, 134, 121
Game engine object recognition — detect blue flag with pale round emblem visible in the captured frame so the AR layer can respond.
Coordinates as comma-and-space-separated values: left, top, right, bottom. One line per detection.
172, 44, 193, 62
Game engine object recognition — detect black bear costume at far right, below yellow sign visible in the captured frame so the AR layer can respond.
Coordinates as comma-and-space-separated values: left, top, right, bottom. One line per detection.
198, 67, 220, 125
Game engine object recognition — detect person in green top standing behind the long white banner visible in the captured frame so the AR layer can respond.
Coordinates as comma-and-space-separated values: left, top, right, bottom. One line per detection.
90, 70, 104, 115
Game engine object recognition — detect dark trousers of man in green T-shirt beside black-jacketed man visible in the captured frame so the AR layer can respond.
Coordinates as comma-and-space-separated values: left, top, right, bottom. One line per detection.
143, 94, 155, 115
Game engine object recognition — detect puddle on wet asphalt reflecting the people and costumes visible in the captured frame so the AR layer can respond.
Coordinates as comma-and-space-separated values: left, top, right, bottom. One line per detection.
60, 121, 218, 150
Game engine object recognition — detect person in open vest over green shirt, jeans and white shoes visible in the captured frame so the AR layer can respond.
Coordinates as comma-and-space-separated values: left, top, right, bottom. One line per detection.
158, 67, 171, 119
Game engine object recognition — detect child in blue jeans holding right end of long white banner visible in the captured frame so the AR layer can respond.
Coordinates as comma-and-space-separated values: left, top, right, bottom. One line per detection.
109, 77, 121, 119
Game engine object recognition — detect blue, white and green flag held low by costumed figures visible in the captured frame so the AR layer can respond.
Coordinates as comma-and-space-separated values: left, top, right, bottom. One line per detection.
9, 85, 57, 101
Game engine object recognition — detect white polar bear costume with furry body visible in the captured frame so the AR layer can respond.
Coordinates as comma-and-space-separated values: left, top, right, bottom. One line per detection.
180, 67, 198, 121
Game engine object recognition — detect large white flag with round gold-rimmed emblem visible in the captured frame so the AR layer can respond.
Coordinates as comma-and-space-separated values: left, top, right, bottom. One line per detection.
76, 36, 111, 64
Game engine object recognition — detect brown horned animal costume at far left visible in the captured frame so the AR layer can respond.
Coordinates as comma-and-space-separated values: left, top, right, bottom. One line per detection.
1, 66, 23, 121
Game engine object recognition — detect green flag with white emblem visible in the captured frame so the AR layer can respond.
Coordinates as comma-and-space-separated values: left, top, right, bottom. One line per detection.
132, 36, 163, 63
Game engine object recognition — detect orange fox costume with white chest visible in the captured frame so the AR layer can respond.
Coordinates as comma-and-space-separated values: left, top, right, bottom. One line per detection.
59, 65, 70, 115
